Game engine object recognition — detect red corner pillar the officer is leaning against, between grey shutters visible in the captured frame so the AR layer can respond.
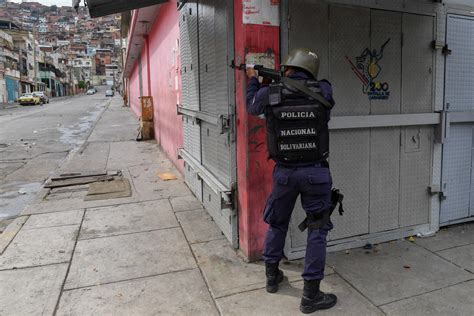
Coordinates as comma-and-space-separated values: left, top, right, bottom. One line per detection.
234, 0, 280, 260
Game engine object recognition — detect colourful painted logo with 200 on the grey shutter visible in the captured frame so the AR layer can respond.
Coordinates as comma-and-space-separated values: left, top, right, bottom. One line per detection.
346, 38, 390, 100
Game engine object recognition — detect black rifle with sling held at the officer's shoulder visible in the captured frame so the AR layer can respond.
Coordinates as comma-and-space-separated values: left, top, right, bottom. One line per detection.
230, 61, 333, 109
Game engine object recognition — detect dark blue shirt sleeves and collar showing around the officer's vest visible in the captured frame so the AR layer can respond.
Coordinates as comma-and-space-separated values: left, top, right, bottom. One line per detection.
247, 72, 335, 118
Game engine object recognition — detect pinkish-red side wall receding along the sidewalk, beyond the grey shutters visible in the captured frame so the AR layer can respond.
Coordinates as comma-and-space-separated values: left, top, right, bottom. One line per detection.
130, 2, 184, 172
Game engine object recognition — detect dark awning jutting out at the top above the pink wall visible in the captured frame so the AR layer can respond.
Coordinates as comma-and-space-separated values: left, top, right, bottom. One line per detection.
87, 0, 167, 18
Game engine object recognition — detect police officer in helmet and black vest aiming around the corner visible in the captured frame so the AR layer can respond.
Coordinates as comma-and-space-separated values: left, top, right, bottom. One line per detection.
247, 48, 337, 313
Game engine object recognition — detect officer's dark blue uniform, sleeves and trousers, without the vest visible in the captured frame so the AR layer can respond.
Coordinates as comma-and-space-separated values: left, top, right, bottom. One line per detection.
247, 72, 334, 280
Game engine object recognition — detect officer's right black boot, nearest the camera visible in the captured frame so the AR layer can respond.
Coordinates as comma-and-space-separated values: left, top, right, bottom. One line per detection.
300, 280, 337, 314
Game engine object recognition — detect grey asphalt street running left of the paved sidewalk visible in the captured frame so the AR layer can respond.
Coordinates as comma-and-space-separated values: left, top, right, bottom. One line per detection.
0, 87, 110, 227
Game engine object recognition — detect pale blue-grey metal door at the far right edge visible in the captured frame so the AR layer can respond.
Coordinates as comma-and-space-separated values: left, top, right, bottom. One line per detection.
440, 15, 474, 225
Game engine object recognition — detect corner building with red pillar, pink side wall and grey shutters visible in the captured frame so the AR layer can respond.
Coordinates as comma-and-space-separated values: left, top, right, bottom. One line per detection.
124, 0, 473, 260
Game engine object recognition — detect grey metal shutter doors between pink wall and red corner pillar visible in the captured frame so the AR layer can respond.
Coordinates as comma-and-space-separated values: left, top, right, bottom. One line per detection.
178, 0, 238, 247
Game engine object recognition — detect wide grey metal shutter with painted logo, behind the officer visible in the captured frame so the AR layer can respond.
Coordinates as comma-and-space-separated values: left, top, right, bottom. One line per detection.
283, 0, 434, 258
